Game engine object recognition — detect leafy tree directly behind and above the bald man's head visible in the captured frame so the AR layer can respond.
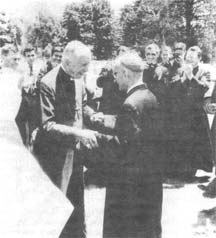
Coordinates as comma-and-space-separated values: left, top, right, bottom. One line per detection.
62, 0, 113, 59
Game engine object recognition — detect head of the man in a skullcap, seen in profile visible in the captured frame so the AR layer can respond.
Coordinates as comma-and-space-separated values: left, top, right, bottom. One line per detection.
114, 53, 143, 91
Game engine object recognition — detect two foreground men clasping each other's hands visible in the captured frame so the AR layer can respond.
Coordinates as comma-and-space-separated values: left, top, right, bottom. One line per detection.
26, 41, 165, 237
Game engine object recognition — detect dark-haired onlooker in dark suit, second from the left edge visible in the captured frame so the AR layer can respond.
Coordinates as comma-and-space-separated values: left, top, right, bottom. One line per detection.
16, 46, 43, 149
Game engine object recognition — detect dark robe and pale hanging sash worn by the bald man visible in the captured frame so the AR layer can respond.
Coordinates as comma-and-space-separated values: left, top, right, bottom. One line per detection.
34, 67, 93, 238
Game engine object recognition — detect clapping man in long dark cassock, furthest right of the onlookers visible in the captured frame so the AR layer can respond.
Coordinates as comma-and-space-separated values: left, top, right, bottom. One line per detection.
169, 46, 212, 178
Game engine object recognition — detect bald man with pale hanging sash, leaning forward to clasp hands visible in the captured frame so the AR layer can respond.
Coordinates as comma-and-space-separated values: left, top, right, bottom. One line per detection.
34, 41, 100, 238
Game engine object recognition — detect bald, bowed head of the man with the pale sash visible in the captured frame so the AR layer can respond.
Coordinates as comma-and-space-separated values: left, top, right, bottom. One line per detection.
62, 41, 91, 78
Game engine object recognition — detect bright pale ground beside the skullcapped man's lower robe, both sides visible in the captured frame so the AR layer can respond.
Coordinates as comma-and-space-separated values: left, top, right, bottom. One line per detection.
85, 172, 216, 238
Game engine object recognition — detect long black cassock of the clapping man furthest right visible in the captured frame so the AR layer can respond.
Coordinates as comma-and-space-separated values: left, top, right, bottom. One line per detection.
167, 66, 212, 176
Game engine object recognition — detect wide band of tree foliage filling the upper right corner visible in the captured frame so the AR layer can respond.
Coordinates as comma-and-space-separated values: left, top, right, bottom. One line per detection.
120, 0, 216, 51
